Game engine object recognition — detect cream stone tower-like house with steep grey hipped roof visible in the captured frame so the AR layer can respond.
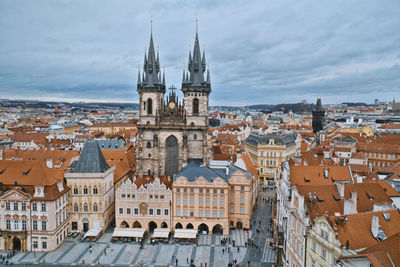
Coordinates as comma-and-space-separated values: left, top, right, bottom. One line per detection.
65, 140, 115, 236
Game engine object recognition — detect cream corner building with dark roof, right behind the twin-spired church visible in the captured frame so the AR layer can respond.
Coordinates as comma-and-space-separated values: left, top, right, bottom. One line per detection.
243, 133, 300, 185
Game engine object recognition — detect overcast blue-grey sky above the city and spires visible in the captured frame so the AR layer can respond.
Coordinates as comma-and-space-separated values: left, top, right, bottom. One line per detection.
0, 0, 400, 105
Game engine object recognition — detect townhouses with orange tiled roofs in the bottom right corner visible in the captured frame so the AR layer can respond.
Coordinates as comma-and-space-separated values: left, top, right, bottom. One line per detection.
275, 163, 400, 267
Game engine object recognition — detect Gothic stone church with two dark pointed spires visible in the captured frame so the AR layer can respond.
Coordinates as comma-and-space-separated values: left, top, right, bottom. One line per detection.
136, 29, 211, 177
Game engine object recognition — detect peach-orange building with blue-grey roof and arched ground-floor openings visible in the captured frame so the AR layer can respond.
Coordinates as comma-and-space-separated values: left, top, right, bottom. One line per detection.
172, 161, 256, 235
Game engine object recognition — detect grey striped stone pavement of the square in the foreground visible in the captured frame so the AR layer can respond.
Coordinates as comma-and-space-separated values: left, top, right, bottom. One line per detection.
12, 230, 255, 267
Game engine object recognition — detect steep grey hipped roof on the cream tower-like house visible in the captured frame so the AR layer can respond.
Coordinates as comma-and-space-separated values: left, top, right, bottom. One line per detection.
72, 140, 109, 173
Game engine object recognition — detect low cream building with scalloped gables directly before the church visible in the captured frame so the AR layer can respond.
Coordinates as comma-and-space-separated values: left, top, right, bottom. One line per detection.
115, 177, 172, 232
